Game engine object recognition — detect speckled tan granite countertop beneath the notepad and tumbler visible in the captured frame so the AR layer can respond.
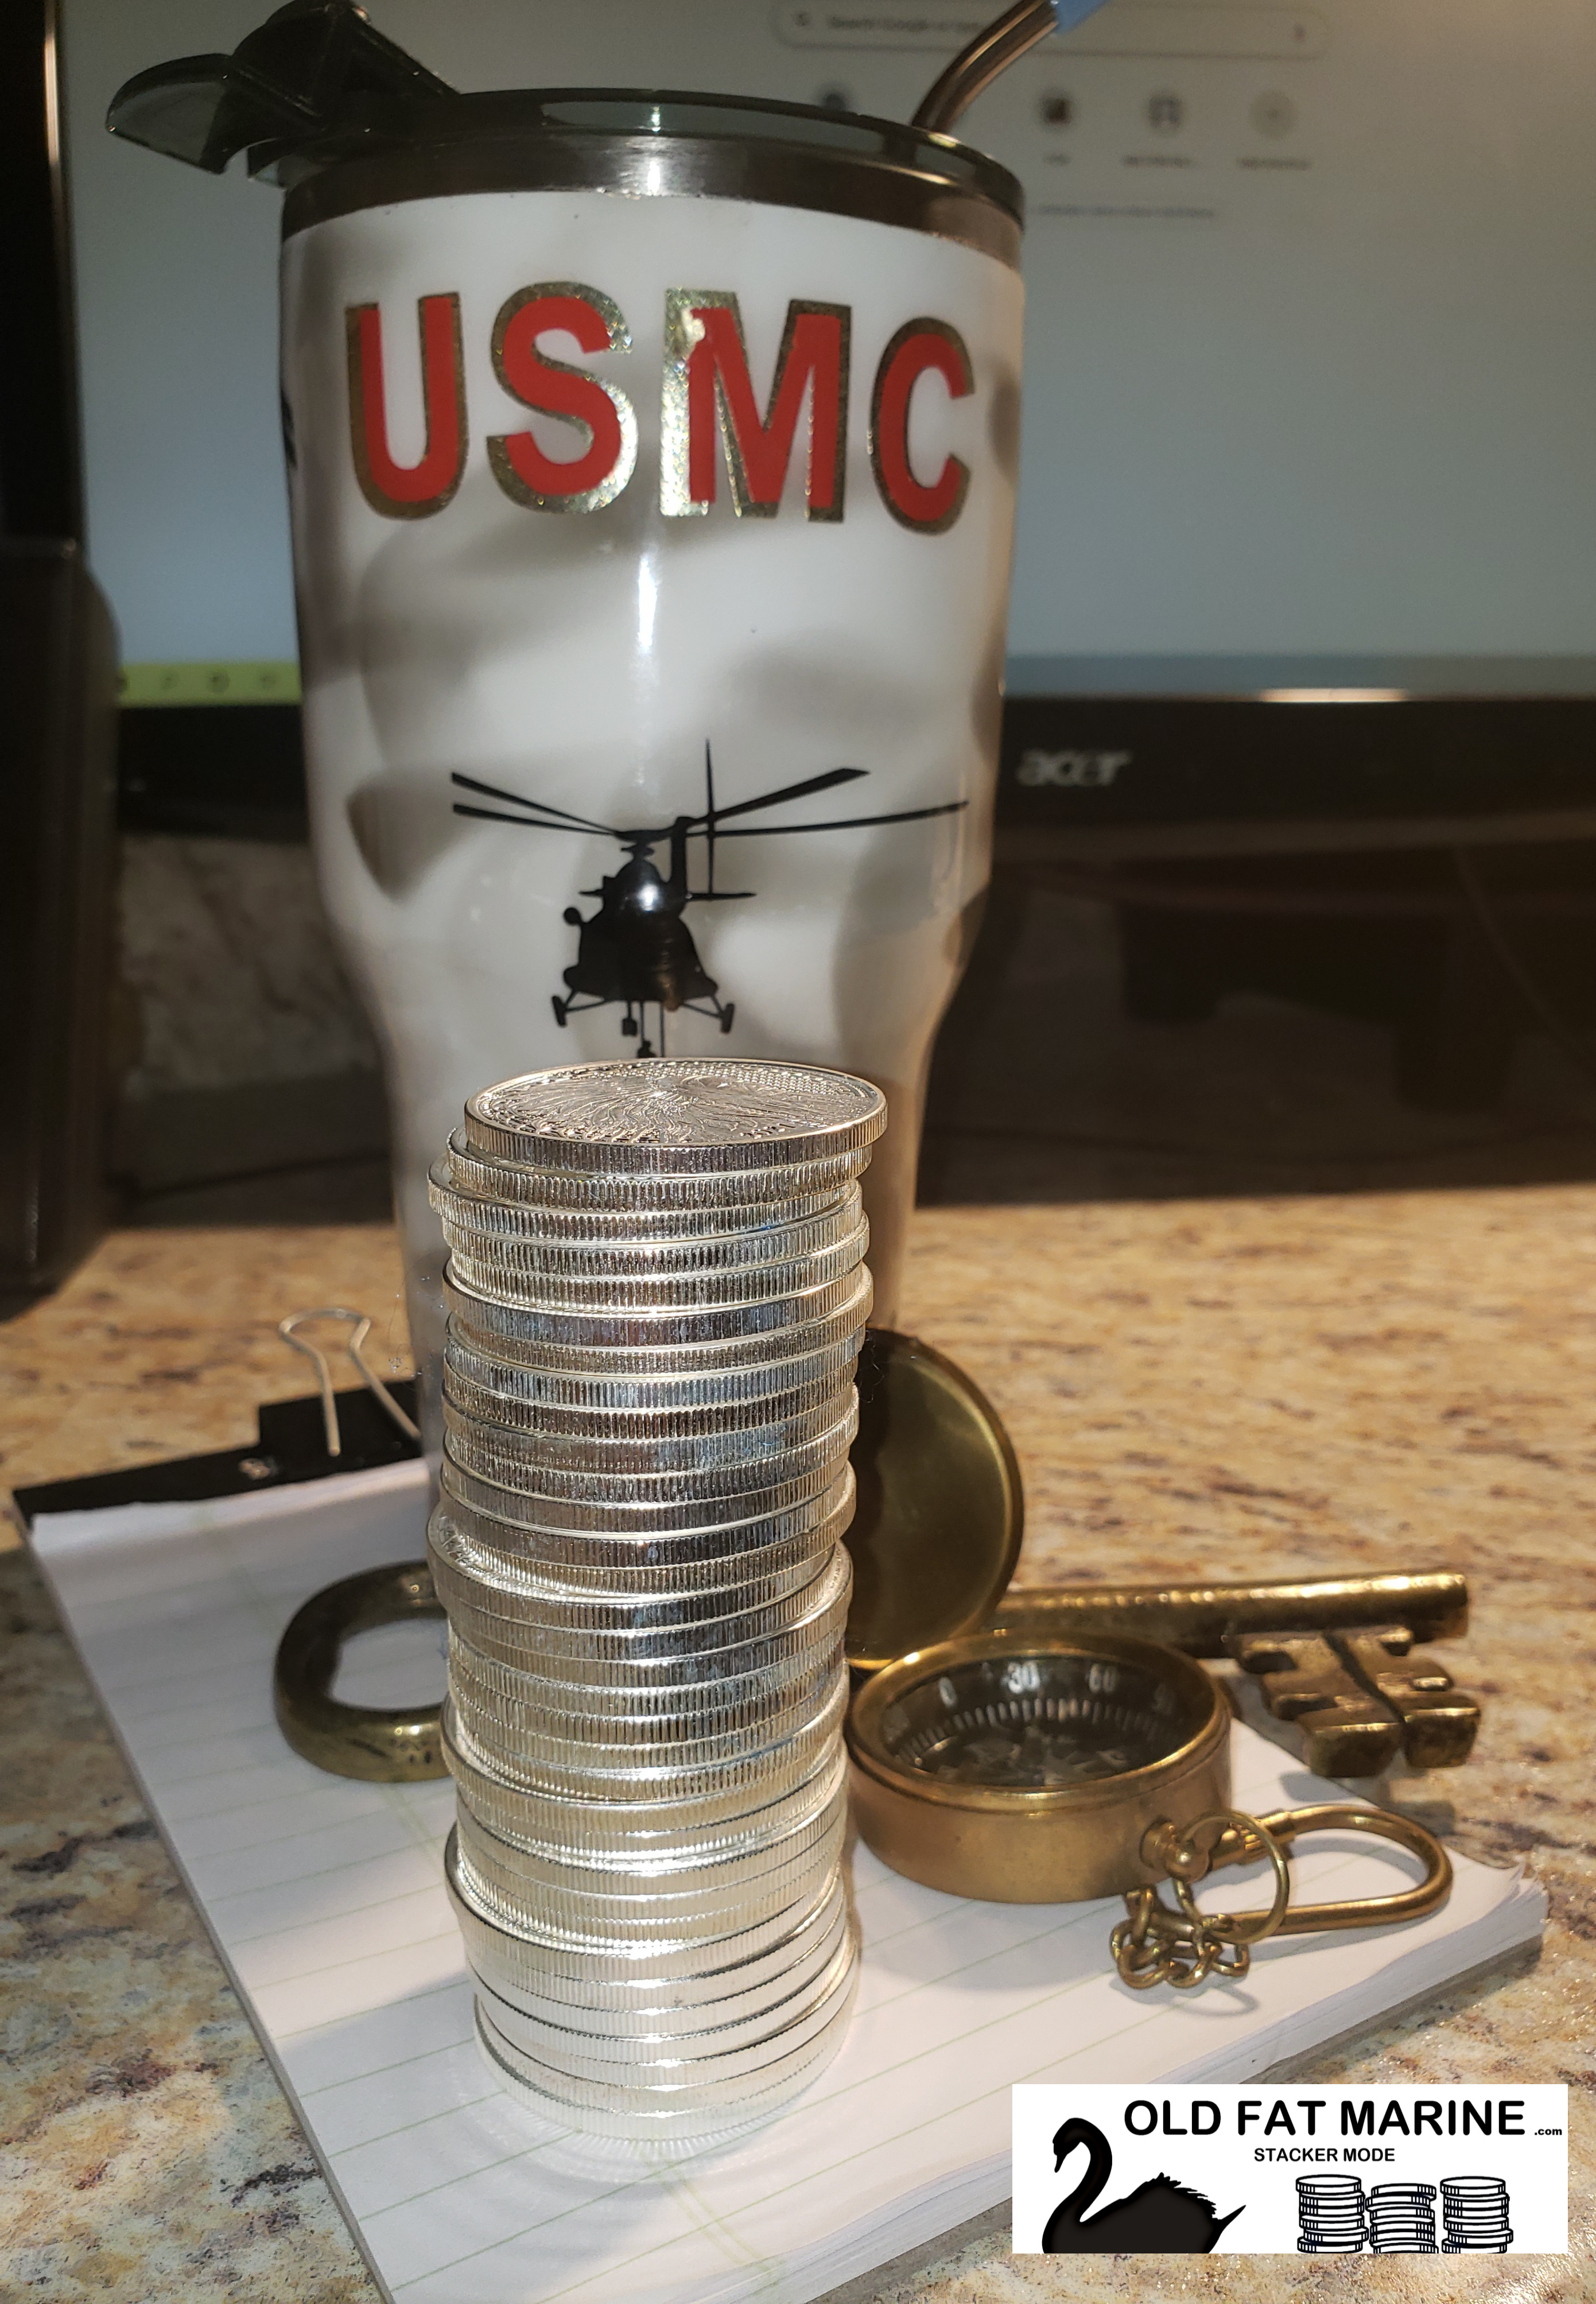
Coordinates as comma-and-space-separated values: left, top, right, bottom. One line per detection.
0, 1186, 1596, 2304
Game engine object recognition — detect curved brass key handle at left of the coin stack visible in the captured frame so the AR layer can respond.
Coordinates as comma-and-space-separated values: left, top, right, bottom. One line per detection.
272, 1560, 447, 1783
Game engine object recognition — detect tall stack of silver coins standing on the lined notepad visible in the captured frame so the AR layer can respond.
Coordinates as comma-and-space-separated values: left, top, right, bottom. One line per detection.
428, 1057, 884, 2138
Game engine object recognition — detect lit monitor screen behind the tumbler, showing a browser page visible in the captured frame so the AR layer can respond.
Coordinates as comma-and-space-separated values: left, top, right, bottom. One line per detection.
64, 0, 1596, 698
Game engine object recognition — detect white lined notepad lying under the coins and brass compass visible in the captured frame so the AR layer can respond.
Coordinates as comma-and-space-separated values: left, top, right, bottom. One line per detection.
34, 1465, 1543, 2304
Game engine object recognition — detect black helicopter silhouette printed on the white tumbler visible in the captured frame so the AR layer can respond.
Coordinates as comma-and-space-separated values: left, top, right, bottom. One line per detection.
449, 744, 969, 1055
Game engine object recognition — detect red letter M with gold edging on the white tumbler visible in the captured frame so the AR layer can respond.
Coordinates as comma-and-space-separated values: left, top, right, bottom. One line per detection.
661, 288, 852, 521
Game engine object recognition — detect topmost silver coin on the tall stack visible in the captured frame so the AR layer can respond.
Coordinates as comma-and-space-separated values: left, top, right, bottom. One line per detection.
461, 1055, 887, 1173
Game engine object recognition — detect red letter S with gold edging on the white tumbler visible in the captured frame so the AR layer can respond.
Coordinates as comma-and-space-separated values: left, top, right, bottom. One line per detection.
488, 281, 638, 511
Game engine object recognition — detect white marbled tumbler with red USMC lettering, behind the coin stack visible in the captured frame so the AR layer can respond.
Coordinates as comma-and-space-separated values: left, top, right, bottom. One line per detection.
270, 92, 1023, 1438
